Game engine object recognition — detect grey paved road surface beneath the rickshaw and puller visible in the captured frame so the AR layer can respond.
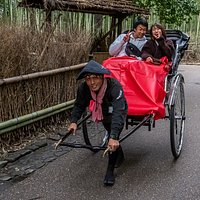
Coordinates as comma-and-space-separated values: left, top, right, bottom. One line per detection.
0, 65, 200, 200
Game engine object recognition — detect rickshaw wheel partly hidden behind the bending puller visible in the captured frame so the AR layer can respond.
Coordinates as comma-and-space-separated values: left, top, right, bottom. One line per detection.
82, 111, 108, 152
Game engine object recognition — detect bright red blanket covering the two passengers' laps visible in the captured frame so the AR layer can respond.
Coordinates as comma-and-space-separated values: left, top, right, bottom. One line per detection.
103, 57, 167, 119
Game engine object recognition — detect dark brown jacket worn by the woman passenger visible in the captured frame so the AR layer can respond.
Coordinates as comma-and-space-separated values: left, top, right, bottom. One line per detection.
141, 37, 175, 61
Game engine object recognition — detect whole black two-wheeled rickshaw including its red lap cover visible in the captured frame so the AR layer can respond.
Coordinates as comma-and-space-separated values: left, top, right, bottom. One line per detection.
55, 30, 190, 159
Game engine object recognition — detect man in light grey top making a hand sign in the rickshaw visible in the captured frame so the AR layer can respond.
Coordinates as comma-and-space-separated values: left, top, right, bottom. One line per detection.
109, 18, 148, 59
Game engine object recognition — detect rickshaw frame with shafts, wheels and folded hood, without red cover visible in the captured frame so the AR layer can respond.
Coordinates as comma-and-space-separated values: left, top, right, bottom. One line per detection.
55, 30, 190, 159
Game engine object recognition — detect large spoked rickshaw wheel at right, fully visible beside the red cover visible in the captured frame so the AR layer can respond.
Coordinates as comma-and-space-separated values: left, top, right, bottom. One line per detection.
169, 79, 185, 159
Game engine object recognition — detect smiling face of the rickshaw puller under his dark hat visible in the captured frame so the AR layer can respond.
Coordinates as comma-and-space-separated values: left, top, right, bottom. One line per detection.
85, 74, 103, 92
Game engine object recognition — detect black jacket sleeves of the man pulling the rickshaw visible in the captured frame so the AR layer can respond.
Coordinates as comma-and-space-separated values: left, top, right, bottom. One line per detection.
70, 78, 127, 139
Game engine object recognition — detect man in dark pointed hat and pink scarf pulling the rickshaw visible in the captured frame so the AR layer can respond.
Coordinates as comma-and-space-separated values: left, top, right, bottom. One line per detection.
68, 60, 127, 185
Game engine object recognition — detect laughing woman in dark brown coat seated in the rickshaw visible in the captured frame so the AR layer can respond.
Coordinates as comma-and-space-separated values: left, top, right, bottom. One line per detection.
142, 23, 175, 64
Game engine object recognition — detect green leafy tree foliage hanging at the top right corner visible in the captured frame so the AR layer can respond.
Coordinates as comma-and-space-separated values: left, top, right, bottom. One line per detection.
134, 0, 200, 25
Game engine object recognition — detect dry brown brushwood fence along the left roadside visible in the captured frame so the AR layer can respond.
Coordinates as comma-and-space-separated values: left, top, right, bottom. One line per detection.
0, 26, 93, 147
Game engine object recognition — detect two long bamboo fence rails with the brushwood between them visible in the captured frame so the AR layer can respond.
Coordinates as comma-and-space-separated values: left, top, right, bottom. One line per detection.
0, 63, 86, 138
